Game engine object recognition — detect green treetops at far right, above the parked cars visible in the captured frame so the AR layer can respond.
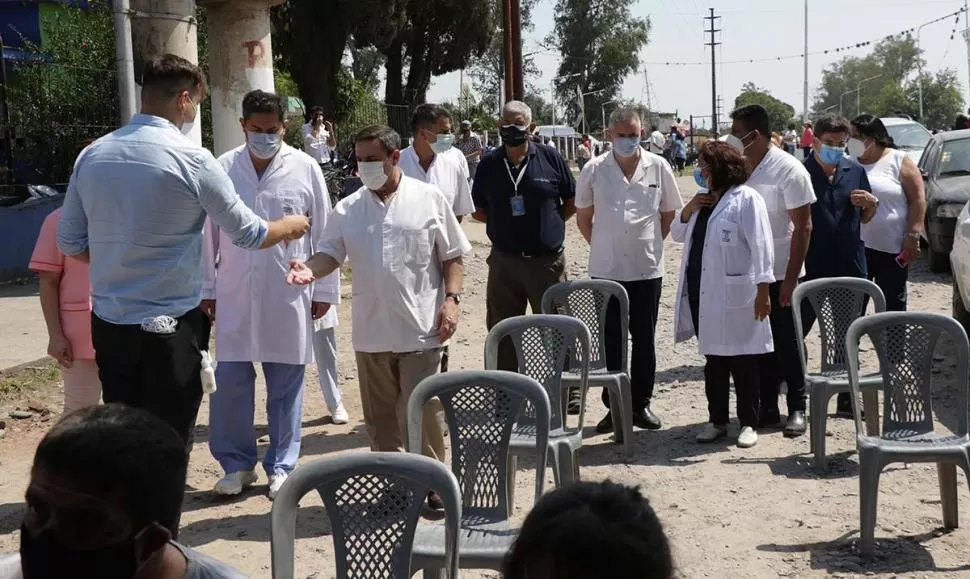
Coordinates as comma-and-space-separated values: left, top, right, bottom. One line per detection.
813, 35, 963, 129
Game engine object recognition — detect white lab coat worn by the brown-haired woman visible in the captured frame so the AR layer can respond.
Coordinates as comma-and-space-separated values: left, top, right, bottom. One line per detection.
670, 185, 775, 356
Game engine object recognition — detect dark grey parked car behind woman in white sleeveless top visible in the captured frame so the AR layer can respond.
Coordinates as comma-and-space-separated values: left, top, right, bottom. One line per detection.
919, 129, 970, 272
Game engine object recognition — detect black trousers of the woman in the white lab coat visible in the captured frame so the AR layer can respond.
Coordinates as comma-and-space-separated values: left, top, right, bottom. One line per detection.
704, 354, 764, 429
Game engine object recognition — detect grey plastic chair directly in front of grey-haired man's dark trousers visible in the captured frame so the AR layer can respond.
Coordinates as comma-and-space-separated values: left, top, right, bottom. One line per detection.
542, 279, 633, 456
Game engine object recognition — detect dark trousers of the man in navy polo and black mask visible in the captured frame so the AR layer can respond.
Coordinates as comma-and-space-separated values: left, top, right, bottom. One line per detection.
485, 249, 566, 372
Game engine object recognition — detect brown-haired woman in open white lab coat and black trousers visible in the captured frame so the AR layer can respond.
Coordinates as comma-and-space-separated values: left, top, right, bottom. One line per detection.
670, 141, 775, 448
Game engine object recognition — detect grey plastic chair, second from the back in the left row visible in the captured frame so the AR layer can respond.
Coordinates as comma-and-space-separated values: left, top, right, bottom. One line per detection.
485, 314, 591, 502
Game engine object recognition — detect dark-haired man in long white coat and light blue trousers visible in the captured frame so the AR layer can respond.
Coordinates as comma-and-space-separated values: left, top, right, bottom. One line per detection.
202, 91, 340, 498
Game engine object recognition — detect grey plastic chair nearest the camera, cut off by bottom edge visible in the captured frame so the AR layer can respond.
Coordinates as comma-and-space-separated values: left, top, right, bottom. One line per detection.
270, 452, 461, 579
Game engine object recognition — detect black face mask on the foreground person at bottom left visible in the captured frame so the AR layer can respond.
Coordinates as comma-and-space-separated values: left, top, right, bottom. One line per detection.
20, 525, 138, 579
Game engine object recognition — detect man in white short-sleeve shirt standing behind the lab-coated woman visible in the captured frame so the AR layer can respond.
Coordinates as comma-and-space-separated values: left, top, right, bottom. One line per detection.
728, 105, 815, 437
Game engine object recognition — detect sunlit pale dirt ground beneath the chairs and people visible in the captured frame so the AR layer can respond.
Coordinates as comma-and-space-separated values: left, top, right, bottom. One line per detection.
0, 178, 970, 579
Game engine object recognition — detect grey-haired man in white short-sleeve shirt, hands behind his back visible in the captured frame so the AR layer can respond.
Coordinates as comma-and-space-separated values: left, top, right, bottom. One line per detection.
576, 108, 683, 433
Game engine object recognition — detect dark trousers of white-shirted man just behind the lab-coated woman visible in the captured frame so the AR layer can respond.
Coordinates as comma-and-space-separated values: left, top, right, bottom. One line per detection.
760, 281, 815, 416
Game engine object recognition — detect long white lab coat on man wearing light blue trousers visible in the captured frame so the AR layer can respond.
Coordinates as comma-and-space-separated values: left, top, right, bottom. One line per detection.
202, 144, 340, 364
